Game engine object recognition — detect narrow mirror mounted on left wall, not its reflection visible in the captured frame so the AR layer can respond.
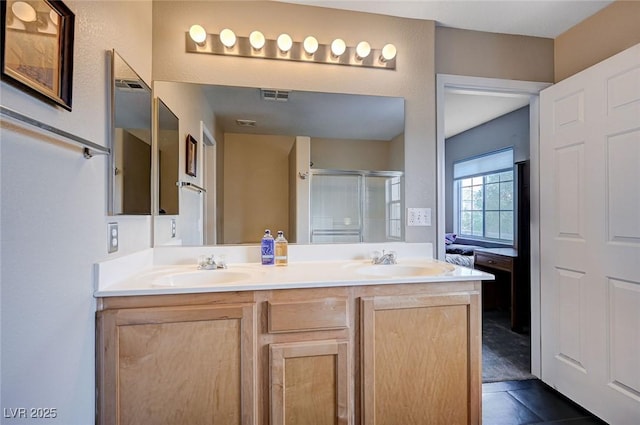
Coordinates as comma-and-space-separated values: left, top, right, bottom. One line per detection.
109, 50, 151, 215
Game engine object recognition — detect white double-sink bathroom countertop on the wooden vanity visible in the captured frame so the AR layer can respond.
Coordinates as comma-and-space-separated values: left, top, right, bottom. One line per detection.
94, 257, 494, 297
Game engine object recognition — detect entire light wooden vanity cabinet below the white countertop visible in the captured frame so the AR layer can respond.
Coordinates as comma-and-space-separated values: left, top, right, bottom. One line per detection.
97, 281, 481, 425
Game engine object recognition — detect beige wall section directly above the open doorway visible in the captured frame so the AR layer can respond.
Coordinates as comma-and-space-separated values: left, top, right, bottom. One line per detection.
435, 27, 553, 82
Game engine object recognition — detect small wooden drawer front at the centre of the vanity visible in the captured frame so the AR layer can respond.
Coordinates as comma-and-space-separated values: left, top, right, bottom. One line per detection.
268, 298, 349, 333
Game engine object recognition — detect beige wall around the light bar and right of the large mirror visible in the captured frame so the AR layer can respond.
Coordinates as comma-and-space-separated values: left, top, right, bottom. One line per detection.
153, 1, 436, 242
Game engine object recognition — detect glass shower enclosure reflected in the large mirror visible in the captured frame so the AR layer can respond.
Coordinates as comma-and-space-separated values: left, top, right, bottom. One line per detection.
310, 169, 404, 243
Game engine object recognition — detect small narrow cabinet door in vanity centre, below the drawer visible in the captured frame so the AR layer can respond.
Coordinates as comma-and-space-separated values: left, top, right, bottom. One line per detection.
270, 340, 353, 425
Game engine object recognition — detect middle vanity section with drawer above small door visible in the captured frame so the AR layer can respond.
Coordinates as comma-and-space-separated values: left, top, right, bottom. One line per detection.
262, 288, 354, 425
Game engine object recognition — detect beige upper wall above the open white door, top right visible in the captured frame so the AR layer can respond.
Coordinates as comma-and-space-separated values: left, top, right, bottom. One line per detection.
555, 0, 640, 81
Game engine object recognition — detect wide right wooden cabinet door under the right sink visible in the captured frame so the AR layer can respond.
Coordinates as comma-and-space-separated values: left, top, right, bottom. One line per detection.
361, 292, 482, 425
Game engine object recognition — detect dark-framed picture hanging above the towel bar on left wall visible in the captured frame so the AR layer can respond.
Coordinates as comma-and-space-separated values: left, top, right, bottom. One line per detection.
0, 0, 75, 111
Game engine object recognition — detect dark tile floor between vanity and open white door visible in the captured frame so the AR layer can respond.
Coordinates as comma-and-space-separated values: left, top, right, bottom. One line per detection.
482, 379, 606, 425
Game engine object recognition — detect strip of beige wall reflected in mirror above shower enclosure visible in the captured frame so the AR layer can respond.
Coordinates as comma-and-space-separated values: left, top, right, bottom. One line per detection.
311, 137, 392, 171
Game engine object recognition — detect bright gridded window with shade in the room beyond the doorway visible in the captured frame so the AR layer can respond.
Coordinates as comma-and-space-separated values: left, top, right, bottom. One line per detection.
453, 149, 514, 243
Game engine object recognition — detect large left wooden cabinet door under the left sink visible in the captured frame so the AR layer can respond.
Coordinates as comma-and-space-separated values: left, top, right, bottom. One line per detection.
98, 304, 256, 425
